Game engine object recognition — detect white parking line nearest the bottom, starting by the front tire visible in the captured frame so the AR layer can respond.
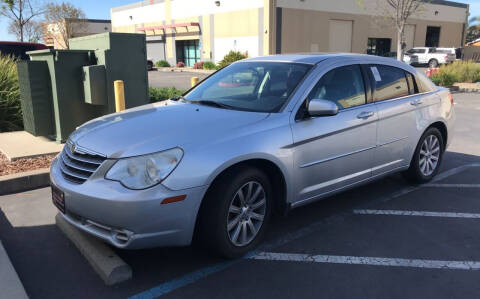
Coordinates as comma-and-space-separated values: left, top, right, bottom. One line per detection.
250, 252, 480, 270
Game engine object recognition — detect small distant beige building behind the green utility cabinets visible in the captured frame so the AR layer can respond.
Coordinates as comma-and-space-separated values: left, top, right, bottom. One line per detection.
42, 19, 112, 49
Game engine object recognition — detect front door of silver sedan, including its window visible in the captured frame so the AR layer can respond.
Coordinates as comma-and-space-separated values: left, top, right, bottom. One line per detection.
291, 61, 377, 205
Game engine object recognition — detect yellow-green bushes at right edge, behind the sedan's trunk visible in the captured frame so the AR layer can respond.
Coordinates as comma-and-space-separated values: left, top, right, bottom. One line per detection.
430, 61, 480, 86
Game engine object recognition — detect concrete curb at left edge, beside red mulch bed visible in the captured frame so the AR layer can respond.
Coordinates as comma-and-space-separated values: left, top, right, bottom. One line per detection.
0, 168, 50, 195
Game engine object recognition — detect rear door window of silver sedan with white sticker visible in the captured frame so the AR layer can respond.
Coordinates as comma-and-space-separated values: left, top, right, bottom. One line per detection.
370, 65, 409, 102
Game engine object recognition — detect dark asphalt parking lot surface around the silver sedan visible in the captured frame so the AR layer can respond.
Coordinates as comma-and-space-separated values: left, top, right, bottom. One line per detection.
0, 93, 480, 298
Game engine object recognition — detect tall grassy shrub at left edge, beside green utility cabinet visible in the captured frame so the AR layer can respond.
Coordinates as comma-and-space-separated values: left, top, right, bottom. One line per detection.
0, 55, 23, 132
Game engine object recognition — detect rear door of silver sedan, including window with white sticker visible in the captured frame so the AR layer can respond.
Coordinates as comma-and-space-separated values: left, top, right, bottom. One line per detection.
366, 65, 419, 176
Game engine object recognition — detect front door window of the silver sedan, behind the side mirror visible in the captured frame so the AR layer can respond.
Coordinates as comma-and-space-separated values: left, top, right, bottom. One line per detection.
308, 65, 366, 109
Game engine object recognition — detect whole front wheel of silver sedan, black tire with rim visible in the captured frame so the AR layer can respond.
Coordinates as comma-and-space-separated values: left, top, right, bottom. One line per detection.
196, 166, 273, 258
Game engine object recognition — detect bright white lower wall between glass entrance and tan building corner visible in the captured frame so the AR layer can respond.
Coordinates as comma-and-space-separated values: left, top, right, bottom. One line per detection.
214, 35, 259, 63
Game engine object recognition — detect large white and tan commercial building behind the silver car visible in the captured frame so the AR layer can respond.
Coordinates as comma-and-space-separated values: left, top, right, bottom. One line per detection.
111, 0, 469, 65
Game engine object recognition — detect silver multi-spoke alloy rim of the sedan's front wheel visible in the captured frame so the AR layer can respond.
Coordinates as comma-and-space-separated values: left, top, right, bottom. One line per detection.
227, 181, 267, 246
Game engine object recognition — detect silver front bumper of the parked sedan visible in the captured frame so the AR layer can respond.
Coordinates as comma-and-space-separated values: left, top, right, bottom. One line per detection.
50, 158, 208, 249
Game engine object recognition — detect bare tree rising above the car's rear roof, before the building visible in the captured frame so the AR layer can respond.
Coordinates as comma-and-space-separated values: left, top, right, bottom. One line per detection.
384, 0, 425, 61
